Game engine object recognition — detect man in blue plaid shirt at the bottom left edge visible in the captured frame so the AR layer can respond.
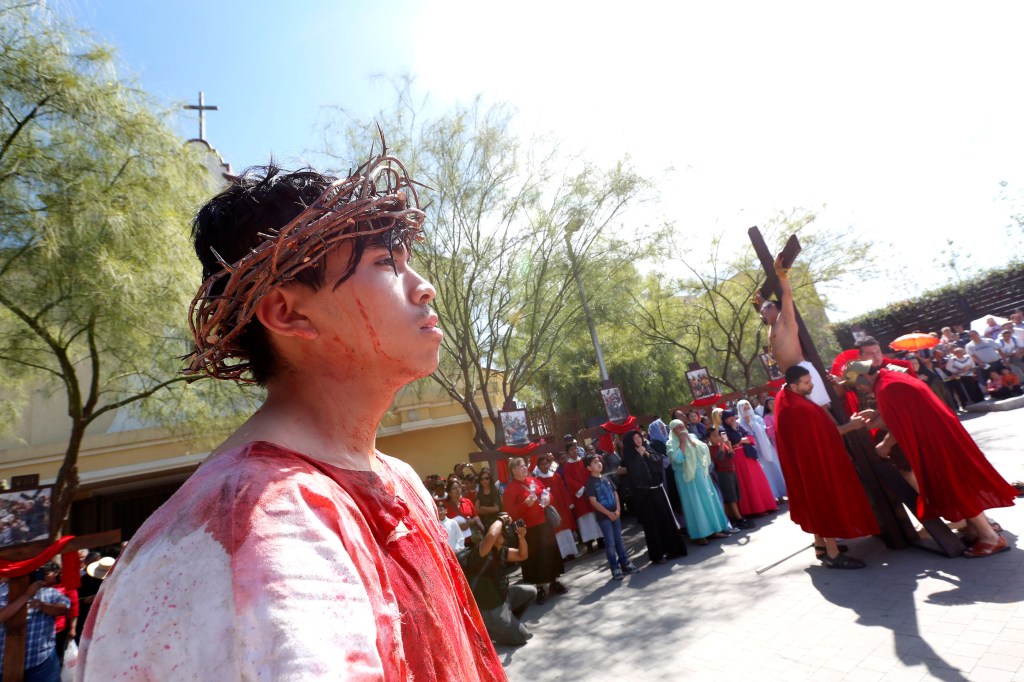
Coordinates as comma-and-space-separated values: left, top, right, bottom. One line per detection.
0, 565, 71, 682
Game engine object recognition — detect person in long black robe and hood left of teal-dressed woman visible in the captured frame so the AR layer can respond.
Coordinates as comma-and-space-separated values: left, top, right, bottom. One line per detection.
623, 431, 686, 563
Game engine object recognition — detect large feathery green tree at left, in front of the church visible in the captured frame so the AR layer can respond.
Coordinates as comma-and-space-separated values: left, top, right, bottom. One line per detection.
0, 2, 247, 518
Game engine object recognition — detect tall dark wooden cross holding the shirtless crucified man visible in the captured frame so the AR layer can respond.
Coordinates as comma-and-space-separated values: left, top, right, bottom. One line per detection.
748, 227, 964, 557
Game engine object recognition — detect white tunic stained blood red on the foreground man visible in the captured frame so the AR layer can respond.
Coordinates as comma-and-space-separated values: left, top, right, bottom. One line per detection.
76, 442, 506, 682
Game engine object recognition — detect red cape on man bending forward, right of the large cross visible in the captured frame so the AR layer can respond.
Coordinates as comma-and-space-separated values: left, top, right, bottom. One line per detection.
874, 370, 1017, 521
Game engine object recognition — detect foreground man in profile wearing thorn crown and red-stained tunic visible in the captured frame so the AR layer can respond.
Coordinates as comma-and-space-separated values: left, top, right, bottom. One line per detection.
76, 140, 505, 681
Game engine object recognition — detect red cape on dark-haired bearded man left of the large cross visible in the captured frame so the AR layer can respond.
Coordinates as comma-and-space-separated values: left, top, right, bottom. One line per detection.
775, 387, 881, 538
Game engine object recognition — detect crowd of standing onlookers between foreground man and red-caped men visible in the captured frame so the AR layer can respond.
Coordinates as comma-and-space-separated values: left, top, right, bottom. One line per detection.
424, 397, 802, 645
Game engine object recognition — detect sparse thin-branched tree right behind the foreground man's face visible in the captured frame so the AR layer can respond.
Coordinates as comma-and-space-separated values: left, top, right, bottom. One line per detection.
328, 80, 648, 447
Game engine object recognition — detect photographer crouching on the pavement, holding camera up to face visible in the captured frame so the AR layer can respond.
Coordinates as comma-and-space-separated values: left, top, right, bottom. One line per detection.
466, 514, 537, 645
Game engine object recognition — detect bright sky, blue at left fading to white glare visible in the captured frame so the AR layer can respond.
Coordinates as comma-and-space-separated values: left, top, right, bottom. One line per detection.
66, 0, 1024, 319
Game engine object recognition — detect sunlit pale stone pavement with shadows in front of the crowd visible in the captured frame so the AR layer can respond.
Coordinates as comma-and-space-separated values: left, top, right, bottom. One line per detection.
498, 410, 1024, 682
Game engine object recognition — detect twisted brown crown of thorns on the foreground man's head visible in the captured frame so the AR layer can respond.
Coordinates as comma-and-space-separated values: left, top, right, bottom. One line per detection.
183, 148, 426, 383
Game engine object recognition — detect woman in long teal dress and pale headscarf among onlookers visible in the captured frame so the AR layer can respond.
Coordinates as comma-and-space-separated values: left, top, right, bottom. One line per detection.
668, 419, 729, 545
